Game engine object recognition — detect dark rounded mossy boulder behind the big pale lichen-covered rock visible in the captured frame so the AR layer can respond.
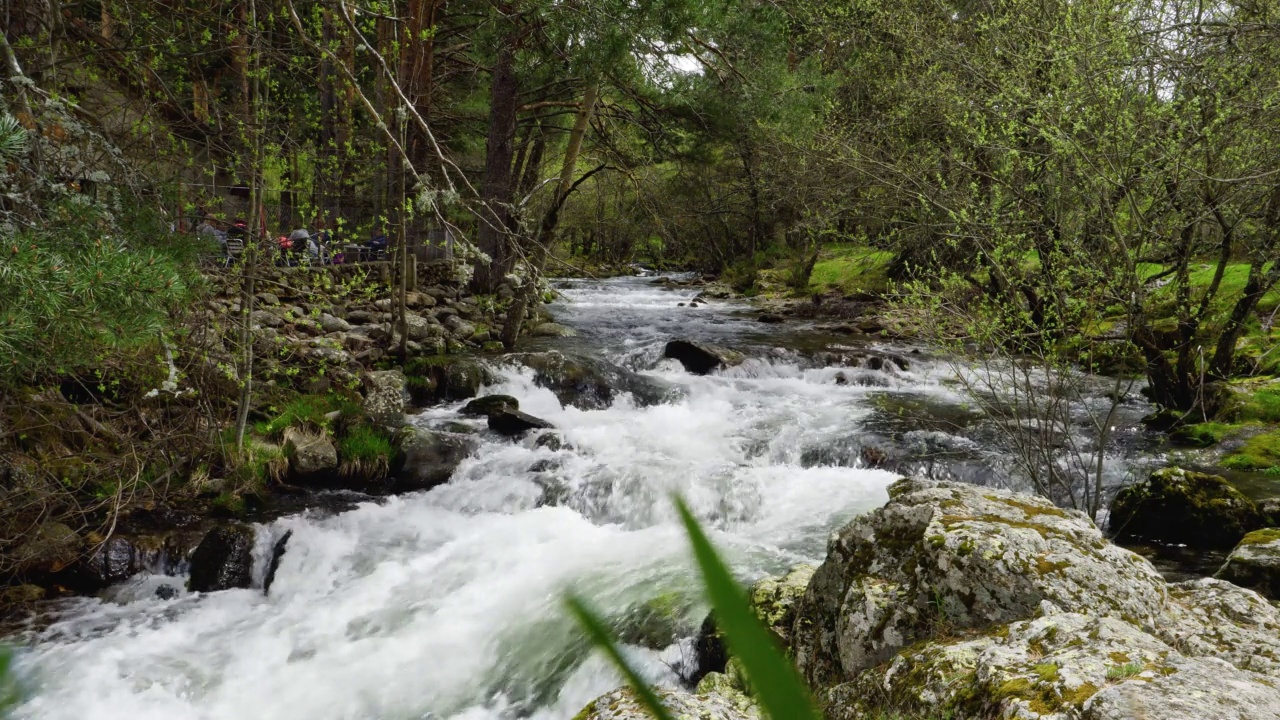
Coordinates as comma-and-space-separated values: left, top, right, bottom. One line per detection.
1108, 468, 1265, 548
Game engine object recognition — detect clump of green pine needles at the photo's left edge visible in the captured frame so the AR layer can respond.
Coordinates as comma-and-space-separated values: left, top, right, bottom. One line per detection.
0, 199, 198, 382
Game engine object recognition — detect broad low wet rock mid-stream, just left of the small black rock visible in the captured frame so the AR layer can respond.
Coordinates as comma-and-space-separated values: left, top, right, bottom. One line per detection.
511, 351, 676, 410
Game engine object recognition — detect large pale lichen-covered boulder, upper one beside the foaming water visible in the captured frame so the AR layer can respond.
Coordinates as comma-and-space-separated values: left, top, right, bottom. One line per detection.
794, 480, 1166, 687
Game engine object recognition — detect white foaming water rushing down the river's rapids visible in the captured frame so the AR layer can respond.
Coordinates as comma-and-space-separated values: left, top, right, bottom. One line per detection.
5, 271, 1157, 720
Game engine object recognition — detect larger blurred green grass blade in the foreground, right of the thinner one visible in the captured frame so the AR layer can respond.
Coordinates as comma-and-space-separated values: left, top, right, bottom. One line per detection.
676, 497, 819, 720
